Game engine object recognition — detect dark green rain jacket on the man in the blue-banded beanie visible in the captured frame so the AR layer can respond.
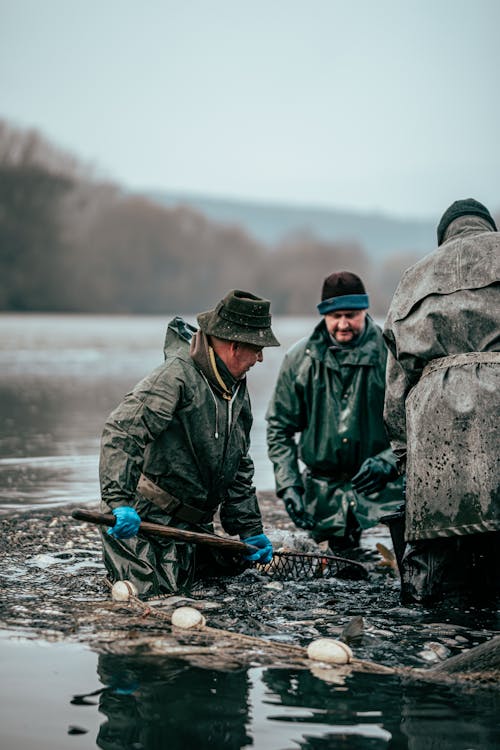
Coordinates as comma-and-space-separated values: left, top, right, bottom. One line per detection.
266, 315, 401, 538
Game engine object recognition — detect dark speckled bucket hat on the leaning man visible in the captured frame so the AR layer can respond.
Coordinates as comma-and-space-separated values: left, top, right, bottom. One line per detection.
197, 289, 280, 346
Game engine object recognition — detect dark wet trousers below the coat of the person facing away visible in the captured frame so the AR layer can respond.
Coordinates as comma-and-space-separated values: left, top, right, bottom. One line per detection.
401, 531, 500, 604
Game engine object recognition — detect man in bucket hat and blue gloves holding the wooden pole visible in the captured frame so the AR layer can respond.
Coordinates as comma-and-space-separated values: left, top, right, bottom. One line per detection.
99, 290, 279, 599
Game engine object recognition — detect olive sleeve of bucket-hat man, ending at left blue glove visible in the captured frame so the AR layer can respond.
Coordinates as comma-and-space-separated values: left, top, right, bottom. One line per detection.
99, 365, 182, 508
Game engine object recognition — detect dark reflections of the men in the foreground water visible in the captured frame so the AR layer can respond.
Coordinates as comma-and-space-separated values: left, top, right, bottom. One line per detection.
87, 654, 500, 750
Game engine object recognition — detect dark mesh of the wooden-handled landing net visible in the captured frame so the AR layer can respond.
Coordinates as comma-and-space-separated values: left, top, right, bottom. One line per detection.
255, 550, 368, 580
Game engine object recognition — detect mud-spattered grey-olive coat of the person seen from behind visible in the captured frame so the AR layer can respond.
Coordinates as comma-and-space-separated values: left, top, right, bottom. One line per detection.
384, 216, 500, 541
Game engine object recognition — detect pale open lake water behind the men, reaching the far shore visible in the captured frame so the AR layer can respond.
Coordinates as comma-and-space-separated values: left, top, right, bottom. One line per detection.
0, 315, 317, 510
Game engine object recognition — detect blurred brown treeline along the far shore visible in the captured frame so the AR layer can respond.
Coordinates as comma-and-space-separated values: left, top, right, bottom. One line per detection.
0, 120, 417, 316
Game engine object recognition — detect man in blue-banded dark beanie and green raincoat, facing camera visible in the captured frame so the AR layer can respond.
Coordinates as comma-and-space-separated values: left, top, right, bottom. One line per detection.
266, 271, 401, 551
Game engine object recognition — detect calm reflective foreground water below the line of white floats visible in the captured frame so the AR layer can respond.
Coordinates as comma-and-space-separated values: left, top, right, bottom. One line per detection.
0, 638, 500, 750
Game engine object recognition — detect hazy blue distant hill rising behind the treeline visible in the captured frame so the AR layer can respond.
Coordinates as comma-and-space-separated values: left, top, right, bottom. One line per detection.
145, 191, 436, 258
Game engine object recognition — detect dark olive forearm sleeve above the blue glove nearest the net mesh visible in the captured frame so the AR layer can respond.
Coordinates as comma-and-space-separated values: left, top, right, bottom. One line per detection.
220, 453, 262, 538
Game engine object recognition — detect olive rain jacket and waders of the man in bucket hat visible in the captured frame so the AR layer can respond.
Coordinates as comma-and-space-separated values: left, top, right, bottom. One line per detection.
99, 318, 262, 597
